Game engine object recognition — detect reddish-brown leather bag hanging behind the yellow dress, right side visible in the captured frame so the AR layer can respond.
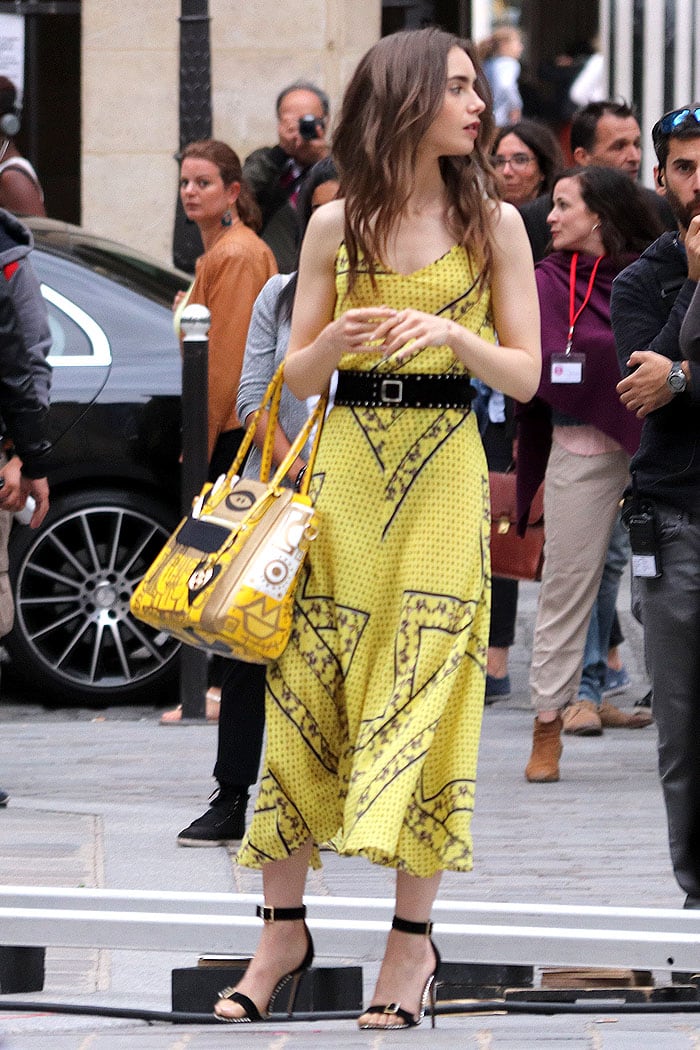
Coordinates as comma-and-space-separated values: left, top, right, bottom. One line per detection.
489, 470, 545, 580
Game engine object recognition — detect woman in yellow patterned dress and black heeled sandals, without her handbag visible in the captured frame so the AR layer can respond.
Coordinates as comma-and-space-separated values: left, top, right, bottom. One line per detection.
215, 29, 539, 1029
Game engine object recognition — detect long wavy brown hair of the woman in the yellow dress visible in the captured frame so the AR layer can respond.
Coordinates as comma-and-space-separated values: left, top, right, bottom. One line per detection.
333, 28, 500, 289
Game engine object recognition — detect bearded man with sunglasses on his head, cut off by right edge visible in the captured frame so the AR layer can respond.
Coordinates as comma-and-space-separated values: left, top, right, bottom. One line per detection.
611, 103, 700, 908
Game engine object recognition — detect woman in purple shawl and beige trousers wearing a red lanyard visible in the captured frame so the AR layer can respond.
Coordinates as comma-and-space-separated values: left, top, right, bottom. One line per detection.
517, 167, 660, 783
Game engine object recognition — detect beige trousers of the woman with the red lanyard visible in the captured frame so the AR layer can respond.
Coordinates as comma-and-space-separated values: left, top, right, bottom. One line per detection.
530, 442, 630, 711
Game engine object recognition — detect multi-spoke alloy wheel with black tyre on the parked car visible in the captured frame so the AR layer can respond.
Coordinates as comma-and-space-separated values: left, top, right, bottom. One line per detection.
5, 489, 179, 706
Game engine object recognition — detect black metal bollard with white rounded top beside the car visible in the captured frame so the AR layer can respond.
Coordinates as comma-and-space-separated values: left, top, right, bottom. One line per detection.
179, 303, 211, 721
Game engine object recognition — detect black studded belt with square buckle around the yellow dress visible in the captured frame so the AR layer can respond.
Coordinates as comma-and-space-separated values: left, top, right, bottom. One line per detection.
334, 370, 475, 413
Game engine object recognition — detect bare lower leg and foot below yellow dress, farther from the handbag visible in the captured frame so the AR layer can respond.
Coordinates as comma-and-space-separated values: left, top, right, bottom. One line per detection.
358, 872, 442, 1027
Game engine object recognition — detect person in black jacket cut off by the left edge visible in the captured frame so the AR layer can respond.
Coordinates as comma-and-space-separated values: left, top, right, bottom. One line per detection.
0, 266, 50, 805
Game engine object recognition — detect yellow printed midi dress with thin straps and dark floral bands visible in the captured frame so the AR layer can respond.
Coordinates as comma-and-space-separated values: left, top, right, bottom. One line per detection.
238, 245, 494, 877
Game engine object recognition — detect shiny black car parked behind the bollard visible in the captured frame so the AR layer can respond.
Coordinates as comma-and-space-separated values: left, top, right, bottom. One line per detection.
3, 218, 190, 705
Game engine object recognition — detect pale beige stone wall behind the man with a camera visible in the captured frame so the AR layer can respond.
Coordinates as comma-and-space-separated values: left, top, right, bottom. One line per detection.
81, 0, 381, 263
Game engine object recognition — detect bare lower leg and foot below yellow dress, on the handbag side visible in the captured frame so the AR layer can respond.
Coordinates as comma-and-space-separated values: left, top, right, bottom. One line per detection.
214, 839, 313, 1019
